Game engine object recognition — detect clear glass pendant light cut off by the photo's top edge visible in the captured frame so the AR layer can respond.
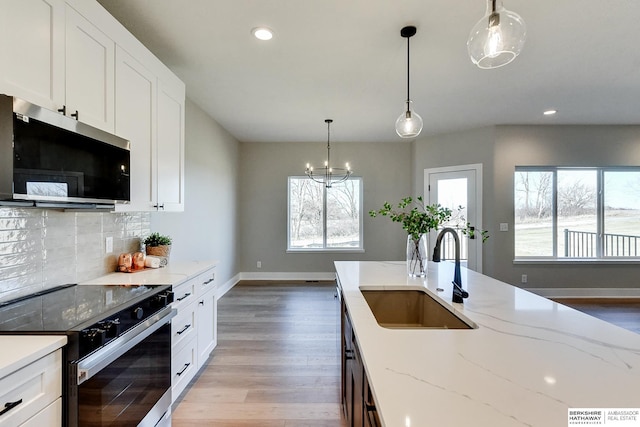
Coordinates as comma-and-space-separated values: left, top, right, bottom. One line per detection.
467, 0, 527, 69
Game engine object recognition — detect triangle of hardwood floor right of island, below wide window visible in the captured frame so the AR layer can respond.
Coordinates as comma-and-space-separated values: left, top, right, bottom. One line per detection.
554, 298, 640, 334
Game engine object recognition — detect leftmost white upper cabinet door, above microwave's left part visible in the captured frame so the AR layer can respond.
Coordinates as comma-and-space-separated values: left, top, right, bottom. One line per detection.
0, 0, 65, 110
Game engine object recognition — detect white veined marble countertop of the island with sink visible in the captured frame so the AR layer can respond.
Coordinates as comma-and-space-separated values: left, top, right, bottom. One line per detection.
335, 261, 640, 427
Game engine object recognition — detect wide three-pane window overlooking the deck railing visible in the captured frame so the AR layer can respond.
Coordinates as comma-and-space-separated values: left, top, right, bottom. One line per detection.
514, 167, 640, 259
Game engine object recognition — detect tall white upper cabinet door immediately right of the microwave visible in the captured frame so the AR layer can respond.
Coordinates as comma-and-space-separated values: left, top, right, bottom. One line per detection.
115, 47, 157, 211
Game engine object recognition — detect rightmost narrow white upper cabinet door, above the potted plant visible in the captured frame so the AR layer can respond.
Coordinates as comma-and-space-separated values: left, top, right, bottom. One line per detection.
157, 81, 185, 211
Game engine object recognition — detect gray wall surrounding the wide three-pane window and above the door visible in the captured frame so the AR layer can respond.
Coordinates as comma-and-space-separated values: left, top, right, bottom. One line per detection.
413, 126, 640, 288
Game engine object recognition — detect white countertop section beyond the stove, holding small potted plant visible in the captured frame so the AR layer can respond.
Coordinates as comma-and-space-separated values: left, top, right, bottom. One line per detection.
81, 261, 217, 285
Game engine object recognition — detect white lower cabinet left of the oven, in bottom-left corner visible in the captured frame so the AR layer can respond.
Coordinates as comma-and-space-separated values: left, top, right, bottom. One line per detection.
0, 350, 62, 427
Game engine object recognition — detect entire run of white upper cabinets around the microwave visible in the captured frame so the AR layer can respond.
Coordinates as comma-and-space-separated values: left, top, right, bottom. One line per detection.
0, 0, 185, 211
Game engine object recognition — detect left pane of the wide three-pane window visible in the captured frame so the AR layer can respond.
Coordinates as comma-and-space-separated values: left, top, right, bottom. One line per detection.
514, 171, 553, 257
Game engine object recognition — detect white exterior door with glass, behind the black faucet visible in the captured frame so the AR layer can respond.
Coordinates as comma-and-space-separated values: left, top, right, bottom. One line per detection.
424, 164, 482, 272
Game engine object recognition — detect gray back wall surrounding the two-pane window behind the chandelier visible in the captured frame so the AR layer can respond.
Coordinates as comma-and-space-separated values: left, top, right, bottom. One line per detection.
239, 141, 411, 273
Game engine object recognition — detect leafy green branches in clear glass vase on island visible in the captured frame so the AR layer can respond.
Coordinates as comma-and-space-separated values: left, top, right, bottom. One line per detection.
369, 196, 452, 277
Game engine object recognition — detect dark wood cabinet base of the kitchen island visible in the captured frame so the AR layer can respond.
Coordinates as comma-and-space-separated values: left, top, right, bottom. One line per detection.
340, 290, 382, 427
